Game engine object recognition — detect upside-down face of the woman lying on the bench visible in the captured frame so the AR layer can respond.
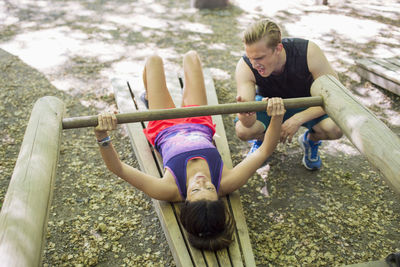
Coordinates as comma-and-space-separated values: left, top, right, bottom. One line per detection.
186, 173, 218, 201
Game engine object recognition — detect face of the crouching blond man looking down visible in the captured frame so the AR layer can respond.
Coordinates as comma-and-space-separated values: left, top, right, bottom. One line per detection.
245, 39, 280, 77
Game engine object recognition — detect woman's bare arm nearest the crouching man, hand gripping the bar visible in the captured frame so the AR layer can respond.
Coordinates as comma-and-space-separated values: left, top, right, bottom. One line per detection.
219, 98, 285, 195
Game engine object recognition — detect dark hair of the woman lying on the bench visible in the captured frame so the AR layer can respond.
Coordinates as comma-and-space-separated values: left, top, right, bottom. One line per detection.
180, 199, 234, 250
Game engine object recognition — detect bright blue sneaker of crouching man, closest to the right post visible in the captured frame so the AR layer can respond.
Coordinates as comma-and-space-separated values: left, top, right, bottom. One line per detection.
298, 131, 322, 171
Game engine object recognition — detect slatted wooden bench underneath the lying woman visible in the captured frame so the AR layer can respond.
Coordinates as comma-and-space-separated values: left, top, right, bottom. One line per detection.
111, 69, 255, 267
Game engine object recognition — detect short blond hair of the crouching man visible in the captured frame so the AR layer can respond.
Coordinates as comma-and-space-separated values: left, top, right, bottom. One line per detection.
243, 19, 282, 49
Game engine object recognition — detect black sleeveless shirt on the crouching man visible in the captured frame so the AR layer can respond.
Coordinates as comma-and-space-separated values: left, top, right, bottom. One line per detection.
243, 38, 314, 98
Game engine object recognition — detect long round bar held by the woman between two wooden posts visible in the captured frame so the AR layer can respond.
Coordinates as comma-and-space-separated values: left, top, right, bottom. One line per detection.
62, 96, 323, 129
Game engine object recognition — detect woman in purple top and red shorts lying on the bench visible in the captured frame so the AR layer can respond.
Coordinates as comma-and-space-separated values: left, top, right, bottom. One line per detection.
95, 51, 285, 250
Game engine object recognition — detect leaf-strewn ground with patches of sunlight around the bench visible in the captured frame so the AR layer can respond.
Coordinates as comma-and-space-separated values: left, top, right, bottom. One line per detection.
0, 0, 400, 266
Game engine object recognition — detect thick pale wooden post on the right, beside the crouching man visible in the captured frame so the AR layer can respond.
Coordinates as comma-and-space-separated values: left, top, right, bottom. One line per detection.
311, 75, 400, 193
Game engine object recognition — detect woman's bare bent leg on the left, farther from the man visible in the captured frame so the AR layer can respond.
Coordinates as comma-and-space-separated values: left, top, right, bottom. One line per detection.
143, 55, 175, 109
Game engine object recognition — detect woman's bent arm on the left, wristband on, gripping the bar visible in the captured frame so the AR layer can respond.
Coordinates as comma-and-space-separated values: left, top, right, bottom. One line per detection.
94, 113, 176, 201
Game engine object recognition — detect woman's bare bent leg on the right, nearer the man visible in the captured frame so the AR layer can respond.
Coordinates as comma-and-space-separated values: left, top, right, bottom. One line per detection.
182, 51, 207, 106
